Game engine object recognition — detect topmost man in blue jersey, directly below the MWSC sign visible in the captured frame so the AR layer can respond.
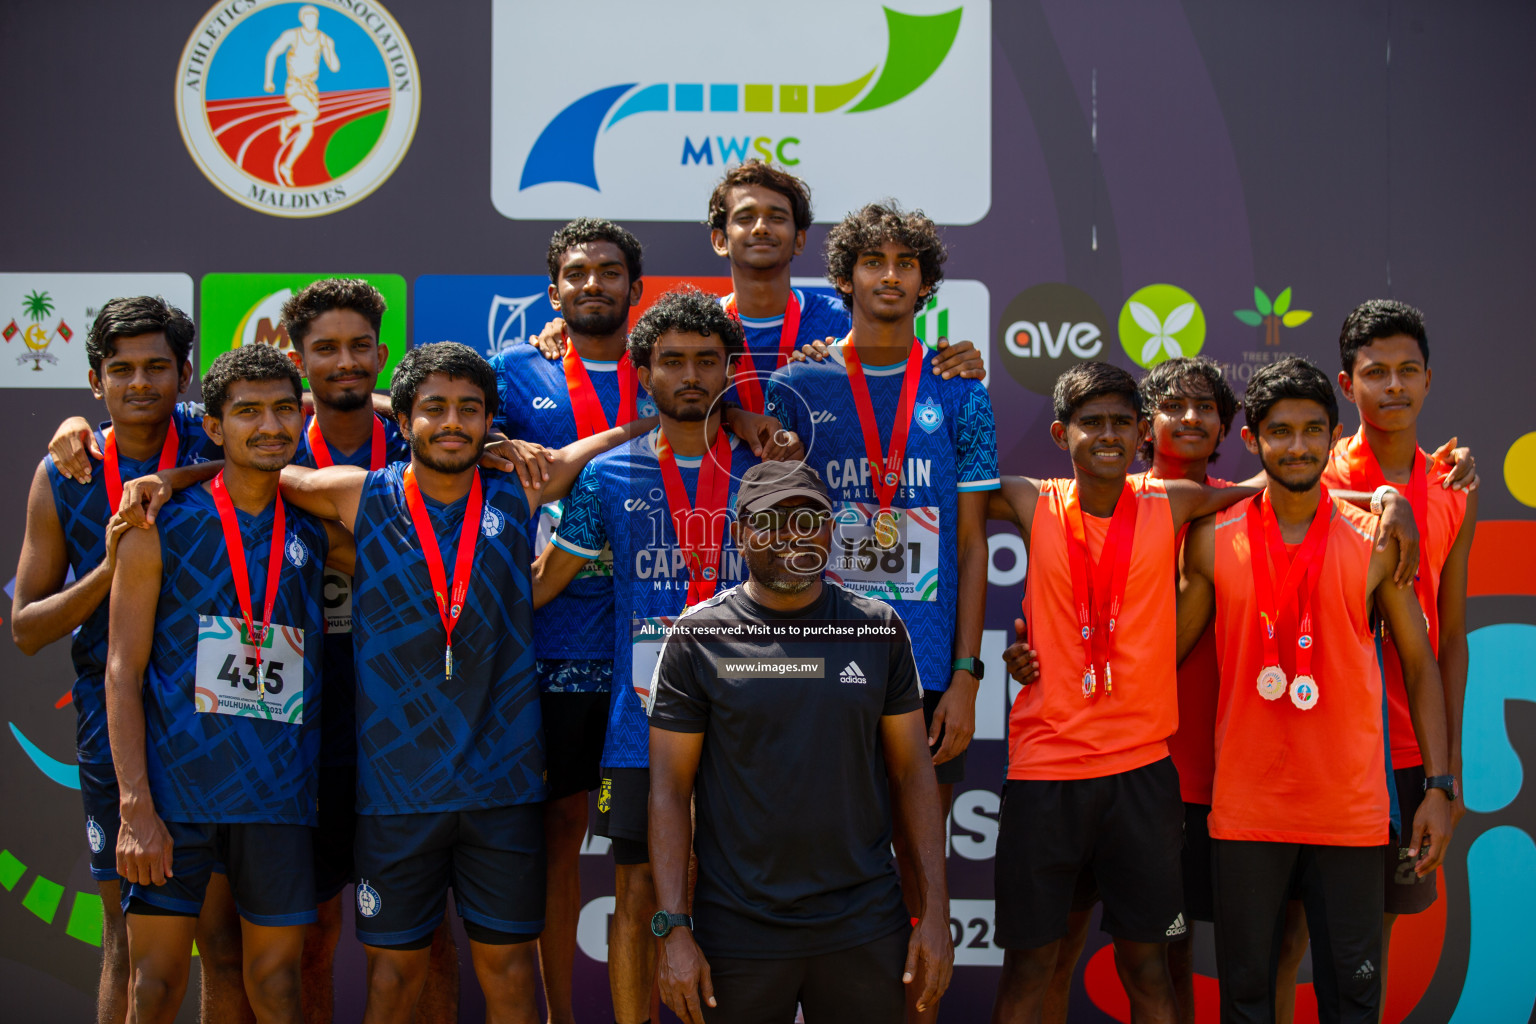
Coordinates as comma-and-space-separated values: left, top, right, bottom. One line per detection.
705, 160, 986, 399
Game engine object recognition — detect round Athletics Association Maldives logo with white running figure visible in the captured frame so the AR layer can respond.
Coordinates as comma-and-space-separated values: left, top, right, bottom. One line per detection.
177, 0, 421, 216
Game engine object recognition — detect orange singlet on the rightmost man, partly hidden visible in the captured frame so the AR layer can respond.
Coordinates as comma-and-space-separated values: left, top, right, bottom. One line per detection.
1322, 427, 1467, 768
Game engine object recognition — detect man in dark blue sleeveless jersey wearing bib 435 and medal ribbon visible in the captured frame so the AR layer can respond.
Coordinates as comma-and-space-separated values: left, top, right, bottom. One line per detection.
106, 345, 352, 1022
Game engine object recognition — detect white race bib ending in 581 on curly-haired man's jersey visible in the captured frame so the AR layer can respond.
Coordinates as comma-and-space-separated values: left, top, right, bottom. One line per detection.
826, 502, 940, 600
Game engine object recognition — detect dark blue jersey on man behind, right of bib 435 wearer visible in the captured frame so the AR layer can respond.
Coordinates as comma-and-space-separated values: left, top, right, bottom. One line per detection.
293, 411, 411, 766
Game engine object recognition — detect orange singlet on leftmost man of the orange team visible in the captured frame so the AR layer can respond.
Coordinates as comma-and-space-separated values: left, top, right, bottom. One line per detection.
1008, 476, 1178, 778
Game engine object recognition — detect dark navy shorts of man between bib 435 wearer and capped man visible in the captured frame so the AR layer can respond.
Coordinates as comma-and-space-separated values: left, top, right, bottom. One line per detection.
355, 803, 545, 949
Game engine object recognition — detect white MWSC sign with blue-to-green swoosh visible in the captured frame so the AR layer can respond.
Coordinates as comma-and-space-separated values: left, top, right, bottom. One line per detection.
492, 0, 991, 224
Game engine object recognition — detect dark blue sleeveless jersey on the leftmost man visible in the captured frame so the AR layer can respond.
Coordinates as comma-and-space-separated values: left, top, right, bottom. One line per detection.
43, 402, 224, 765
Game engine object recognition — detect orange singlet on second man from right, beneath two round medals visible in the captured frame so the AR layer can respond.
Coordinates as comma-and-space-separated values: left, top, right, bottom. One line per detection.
1210, 499, 1390, 846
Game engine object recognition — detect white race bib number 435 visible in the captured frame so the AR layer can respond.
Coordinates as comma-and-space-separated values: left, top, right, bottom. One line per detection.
194, 616, 304, 725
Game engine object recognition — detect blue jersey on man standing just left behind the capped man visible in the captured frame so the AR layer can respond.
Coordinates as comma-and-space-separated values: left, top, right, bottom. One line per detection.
554, 428, 757, 768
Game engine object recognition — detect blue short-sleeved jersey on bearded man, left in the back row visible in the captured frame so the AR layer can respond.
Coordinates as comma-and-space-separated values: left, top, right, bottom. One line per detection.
492, 345, 656, 682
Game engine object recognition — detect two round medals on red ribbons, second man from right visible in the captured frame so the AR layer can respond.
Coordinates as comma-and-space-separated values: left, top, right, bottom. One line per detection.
1244, 487, 1333, 711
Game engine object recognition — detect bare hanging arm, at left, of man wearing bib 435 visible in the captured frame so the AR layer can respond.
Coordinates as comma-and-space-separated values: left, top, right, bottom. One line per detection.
106, 527, 172, 886
